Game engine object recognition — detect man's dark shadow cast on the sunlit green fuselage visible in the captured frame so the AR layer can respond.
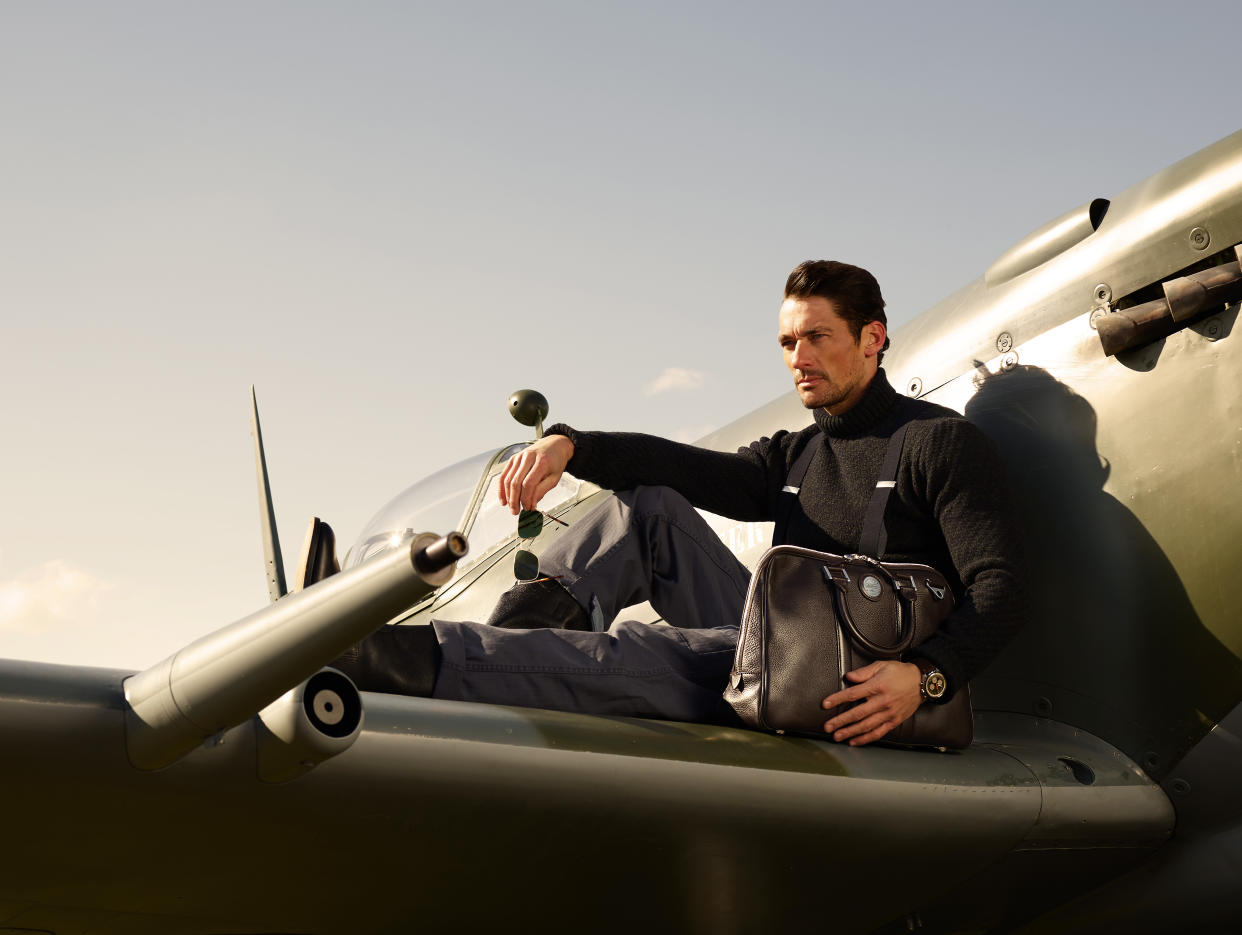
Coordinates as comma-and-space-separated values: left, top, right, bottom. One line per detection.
965, 366, 1242, 776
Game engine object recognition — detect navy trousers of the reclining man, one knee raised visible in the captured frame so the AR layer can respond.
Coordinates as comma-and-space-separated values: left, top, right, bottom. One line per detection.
432, 487, 750, 721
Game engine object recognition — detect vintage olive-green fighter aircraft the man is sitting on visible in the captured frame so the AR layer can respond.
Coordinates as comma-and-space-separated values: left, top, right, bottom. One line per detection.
0, 126, 1242, 935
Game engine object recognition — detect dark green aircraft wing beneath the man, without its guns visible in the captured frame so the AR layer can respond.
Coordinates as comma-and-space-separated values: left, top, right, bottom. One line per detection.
0, 662, 1172, 935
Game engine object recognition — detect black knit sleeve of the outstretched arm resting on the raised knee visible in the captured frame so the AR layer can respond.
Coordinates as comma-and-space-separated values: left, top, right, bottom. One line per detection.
546, 423, 792, 522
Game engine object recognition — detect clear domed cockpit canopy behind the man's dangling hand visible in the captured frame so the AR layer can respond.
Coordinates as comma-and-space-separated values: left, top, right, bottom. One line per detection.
344, 442, 582, 575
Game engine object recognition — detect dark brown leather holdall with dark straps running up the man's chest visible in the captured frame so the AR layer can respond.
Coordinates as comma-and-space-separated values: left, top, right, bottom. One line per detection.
724, 407, 974, 749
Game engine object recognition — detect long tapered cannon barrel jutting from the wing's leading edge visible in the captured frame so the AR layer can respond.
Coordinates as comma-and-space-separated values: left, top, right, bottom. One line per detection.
124, 533, 467, 770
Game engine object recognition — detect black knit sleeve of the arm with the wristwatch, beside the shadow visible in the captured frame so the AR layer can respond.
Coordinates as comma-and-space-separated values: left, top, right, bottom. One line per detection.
915, 420, 1026, 700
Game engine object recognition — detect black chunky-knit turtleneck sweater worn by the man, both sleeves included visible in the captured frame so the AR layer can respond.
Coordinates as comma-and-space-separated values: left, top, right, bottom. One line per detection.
548, 370, 1025, 690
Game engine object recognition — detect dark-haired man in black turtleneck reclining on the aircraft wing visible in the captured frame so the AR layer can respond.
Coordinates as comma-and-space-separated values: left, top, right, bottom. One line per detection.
344, 261, 1022, 745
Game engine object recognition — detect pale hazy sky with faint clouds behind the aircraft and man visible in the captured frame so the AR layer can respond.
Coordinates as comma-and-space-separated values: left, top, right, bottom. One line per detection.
0, 0, 1242, 669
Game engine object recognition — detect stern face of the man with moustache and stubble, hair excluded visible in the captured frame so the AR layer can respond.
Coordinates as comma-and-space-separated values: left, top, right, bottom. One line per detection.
780, 296, 886, 415
